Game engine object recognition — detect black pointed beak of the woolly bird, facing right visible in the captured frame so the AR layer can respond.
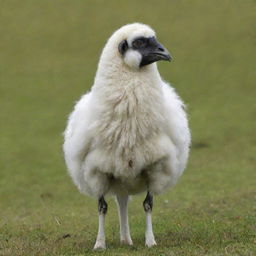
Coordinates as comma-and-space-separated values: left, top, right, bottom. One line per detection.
140, 37, 172, 67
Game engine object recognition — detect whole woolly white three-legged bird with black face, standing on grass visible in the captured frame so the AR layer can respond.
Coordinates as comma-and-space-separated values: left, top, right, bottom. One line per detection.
63, 23, 191, 250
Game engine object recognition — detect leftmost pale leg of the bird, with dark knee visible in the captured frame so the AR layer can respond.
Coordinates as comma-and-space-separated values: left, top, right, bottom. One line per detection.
93, 196, 108, 250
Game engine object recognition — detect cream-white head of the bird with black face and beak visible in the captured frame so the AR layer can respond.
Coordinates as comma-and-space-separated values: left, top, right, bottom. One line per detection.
100, 23, 172, 70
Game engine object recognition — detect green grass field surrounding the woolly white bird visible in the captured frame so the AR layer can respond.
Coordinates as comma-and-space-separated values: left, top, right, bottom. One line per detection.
0, 0, 256, 256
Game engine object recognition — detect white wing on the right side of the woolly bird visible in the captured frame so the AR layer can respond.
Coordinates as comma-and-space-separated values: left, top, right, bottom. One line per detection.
162, 82, 190, 165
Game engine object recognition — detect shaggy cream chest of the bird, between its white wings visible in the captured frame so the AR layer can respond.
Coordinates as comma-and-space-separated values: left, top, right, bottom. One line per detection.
88, 87, 172, 177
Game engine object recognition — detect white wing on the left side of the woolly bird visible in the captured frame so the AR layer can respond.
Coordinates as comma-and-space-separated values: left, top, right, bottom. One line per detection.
63, 92, 92, 184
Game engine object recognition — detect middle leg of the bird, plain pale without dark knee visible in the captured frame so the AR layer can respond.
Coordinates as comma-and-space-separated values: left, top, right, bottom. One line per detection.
116, 195, 133, 245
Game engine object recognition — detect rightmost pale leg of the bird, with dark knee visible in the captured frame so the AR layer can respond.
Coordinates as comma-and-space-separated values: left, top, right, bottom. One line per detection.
143, 191, 156, 247
